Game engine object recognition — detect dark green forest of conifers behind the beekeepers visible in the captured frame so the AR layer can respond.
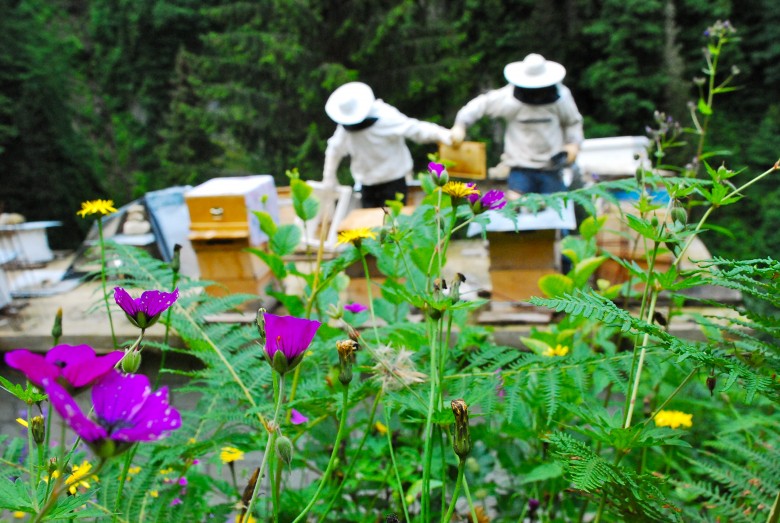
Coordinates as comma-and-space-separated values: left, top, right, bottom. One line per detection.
0, 0, 780, 257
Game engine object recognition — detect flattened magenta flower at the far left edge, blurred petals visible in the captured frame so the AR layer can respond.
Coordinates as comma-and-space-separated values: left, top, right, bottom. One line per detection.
5, 345, 124, 390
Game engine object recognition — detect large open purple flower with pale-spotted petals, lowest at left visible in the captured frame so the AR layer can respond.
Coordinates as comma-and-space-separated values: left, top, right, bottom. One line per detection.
43, 370, 181, 458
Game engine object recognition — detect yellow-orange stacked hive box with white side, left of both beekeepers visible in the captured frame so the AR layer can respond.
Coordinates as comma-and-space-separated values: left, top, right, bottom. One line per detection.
184, 175, 279, 296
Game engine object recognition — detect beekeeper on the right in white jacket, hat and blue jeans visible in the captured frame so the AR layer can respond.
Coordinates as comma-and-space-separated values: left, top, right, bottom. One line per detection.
452, 54, 584, 193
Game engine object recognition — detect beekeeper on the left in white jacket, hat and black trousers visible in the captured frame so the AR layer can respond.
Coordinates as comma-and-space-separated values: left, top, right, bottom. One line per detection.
322, 82, 452, 207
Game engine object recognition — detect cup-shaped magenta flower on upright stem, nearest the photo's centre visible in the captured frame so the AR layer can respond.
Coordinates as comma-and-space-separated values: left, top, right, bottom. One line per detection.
263, 312, 322, 374
